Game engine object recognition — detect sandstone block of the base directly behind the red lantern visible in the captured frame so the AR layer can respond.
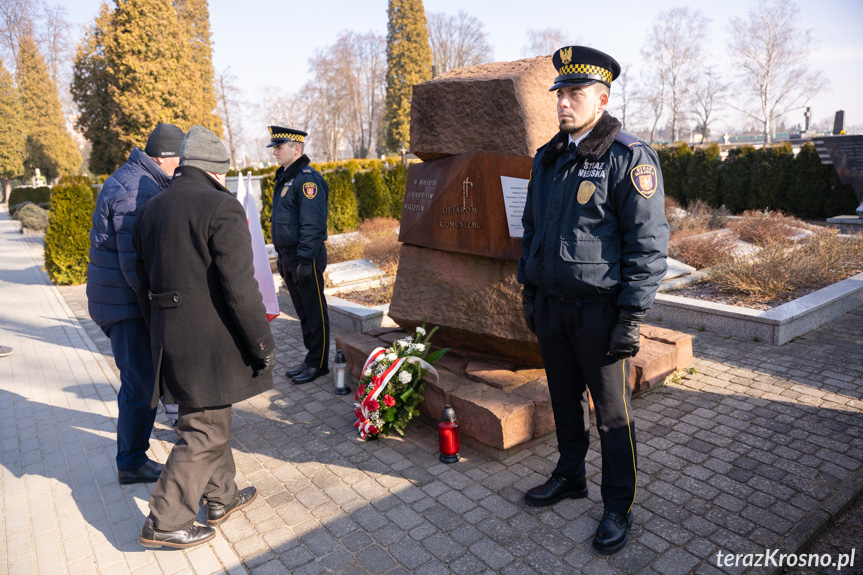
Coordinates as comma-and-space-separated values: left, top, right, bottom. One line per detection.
450, 383, 536, 449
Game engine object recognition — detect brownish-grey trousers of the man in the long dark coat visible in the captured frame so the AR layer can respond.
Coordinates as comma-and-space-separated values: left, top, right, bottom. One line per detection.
150, 405, 238, 531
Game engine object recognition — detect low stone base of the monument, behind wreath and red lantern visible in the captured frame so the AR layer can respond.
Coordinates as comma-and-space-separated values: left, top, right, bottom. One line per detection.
336, 325, 693, 460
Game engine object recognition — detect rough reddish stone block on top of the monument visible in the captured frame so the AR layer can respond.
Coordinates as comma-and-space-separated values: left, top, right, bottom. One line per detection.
410, 56, 558, 160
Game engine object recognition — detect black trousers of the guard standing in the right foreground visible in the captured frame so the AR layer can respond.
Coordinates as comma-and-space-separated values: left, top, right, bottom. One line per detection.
536, 291, 638, 513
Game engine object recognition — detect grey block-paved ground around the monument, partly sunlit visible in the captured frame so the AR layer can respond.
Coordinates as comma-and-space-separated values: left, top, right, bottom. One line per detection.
0, 205, 863, 575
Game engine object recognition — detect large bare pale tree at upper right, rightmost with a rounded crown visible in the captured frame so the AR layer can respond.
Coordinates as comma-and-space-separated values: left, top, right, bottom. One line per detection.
728, 0, 824, 143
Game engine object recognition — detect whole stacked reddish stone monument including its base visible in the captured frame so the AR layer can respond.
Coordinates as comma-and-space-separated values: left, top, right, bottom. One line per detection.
336, 57, 692, 458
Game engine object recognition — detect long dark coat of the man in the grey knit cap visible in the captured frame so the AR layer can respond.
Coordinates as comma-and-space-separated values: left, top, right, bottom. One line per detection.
134, 166, 273, 407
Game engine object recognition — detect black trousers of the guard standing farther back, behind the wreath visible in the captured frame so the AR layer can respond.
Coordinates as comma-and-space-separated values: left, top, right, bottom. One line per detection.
278, 246, 330, 369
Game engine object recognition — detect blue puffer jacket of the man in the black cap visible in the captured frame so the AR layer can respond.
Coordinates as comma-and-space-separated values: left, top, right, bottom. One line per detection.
87, 148, 171, 325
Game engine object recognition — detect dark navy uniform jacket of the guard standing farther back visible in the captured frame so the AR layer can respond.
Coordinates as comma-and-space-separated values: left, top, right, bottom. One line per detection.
272, 155, 330, 263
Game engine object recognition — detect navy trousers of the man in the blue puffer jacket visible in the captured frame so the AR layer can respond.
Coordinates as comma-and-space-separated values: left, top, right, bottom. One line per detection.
102, 319, 156, 471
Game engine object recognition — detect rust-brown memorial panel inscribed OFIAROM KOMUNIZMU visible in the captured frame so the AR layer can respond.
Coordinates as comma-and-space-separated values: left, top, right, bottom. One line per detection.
399, 152, 533, 260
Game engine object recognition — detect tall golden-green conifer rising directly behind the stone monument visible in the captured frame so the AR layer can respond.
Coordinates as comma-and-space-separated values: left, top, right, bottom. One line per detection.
384, 0, 432, 152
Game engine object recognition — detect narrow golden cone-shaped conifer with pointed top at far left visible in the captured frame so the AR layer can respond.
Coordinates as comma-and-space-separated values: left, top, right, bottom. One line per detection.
16, 36, 81, 180
